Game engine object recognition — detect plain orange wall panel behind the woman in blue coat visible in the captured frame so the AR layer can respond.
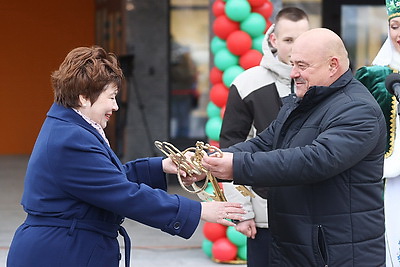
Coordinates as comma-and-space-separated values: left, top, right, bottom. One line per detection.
0, 0, 95, 154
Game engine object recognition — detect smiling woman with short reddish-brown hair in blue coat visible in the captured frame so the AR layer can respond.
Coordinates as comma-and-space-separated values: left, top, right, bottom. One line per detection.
7, 47, 243, 267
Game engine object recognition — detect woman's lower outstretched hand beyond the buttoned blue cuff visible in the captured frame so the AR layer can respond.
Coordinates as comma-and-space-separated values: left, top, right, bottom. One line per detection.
201, 201, 246, 226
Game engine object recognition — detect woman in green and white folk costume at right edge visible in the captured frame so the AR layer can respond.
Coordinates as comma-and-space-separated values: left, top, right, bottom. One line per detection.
355, 0, 400, 266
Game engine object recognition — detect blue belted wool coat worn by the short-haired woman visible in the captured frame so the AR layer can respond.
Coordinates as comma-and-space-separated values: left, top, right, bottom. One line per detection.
7, 104, 201, 267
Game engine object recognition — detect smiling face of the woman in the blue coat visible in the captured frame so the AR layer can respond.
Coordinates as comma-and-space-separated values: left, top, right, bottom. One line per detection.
79, 84, 118, 129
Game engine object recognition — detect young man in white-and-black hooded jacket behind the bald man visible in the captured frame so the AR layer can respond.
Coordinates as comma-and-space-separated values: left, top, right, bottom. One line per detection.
220, 7, 309, 267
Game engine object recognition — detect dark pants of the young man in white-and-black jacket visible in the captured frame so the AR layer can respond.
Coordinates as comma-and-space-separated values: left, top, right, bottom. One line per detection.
247, 227, 271, 267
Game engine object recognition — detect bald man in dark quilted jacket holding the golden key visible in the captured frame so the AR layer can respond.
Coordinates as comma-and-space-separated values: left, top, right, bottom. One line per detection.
203, 28, 386, 266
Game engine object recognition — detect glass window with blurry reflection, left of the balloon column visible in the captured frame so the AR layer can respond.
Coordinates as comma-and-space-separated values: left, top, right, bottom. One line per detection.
170, 0, 209, 139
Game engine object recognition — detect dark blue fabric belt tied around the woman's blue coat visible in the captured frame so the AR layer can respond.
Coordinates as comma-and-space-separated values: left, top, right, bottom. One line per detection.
25, 214, 131, 267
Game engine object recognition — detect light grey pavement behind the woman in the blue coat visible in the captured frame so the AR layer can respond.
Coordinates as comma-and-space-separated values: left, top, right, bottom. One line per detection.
0, 156, 246, 267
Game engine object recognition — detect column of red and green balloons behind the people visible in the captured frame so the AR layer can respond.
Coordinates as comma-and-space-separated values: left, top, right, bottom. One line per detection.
202, 0, 273, 264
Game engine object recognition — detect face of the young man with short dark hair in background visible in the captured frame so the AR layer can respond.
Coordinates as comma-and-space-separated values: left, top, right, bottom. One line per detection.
270, 18, 309, 64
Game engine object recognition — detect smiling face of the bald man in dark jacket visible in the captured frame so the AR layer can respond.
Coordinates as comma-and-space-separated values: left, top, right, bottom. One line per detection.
290, 45, 332, 98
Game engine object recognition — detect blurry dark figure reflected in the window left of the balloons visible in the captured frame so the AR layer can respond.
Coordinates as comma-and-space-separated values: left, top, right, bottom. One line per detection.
170, 38, 199, 138
